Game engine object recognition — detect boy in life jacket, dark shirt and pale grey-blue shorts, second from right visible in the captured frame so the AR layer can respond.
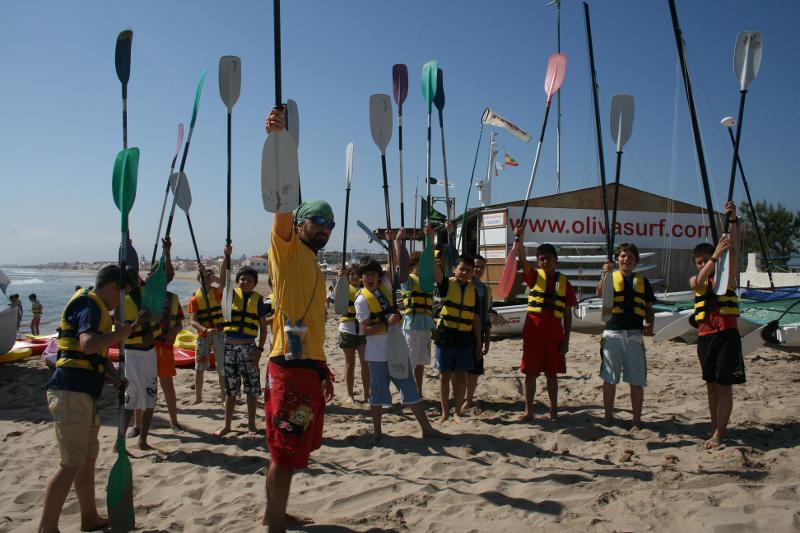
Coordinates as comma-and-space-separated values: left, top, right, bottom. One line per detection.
597, 243, 656, 429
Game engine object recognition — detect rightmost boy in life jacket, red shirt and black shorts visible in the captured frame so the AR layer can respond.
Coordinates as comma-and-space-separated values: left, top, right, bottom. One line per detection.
689, 202, 746, 450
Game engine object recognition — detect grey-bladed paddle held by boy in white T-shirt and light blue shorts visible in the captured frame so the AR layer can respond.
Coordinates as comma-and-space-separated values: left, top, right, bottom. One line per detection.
369, 94, 410, 379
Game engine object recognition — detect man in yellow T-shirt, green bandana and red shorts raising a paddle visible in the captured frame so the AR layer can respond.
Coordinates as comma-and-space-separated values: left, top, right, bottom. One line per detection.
263, 106, 335, 531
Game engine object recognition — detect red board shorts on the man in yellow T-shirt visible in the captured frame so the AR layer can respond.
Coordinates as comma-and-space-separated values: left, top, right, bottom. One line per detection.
264, 359, 327, 470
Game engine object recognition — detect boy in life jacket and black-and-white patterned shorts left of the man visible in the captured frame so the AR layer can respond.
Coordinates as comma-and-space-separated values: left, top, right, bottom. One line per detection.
214, 260, 272, 437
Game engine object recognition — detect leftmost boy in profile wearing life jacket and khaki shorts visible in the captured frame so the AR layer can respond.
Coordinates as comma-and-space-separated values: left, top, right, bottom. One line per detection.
39, 265, 137, 531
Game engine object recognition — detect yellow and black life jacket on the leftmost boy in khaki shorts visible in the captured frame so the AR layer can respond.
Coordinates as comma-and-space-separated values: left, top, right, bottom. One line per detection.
56, 289, 112, 374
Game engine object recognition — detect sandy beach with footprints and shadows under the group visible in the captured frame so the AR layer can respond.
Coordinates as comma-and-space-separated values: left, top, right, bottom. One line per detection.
0, 317, 800, 532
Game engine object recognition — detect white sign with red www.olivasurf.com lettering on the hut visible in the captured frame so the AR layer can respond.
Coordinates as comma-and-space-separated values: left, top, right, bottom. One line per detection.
508, 207, 711, 250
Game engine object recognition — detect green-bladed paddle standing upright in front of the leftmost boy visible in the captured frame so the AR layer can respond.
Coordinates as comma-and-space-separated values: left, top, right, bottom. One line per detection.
106, 148, 139, 532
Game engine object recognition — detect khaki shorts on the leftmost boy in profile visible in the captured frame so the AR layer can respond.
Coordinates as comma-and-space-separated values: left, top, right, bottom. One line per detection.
47, 390, 100, 468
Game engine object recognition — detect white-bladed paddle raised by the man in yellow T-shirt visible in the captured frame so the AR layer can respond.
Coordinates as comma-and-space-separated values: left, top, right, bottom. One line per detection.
261, 0, 300, 213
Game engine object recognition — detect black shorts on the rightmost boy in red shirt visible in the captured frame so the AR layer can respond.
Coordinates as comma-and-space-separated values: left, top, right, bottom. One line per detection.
697, 329, 747, 385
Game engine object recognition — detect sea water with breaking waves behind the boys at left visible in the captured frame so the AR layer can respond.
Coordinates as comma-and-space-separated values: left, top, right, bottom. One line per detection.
0, 268, 198, 335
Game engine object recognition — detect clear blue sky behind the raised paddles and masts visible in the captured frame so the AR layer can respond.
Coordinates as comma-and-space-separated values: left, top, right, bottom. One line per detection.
0, 0, 800, 263
